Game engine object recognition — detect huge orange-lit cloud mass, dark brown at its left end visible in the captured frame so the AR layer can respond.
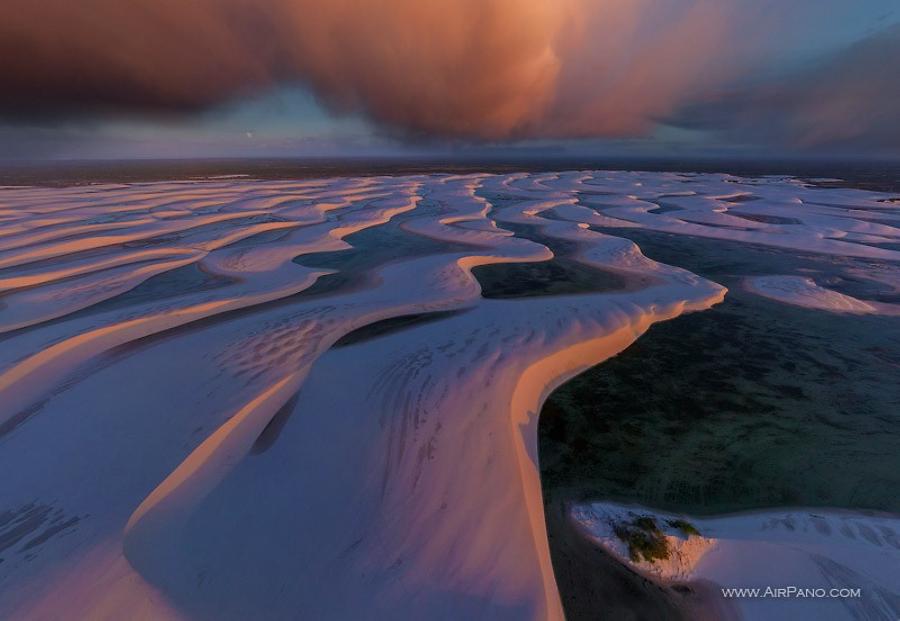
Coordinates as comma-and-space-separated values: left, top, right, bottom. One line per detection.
0, 0, 880, 140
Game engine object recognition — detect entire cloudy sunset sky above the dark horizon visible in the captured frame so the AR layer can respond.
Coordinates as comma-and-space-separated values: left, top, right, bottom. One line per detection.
0, 0, 900, 160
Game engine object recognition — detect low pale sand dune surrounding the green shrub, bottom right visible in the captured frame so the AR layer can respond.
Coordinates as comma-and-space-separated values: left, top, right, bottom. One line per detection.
572, 503, 900, 621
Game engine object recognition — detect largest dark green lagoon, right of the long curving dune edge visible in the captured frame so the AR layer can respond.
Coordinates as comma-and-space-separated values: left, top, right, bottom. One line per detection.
539, 231, 900, 514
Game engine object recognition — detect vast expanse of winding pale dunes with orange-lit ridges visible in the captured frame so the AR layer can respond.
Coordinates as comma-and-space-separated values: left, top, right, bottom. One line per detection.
0, 171, 900, 620
